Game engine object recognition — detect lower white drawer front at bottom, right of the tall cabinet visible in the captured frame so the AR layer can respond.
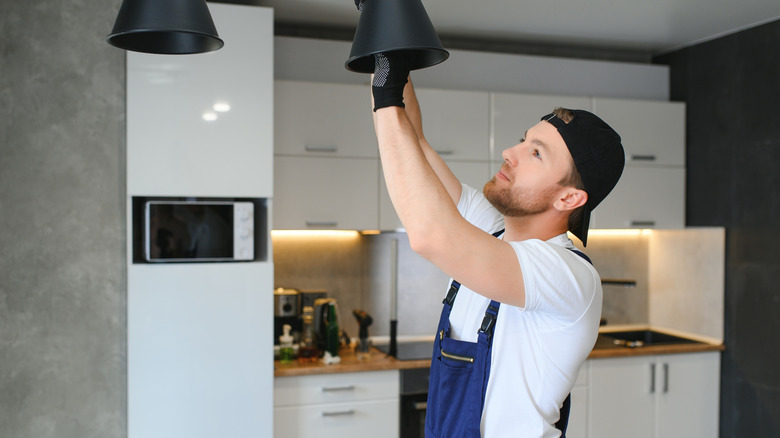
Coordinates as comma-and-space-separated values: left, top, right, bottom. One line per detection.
274, 399, 399, 438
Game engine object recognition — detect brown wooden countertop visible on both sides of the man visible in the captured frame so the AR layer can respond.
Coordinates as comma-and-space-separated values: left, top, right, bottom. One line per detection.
274, 342, 726, 377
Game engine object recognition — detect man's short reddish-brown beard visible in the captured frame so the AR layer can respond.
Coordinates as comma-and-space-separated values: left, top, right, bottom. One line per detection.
482, 177, 558, 217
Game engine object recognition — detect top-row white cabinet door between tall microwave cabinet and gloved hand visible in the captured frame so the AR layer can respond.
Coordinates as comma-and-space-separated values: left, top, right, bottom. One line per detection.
274, 81, 379, 158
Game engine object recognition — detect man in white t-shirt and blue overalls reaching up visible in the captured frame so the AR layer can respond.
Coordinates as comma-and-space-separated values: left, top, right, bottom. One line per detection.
372, 52, 624, 438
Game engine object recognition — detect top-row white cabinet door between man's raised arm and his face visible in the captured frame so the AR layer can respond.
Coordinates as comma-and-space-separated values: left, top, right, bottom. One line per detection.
415, 89, 490, 162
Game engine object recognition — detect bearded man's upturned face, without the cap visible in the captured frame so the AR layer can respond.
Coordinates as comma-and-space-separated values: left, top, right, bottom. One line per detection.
483, 121, 572, 217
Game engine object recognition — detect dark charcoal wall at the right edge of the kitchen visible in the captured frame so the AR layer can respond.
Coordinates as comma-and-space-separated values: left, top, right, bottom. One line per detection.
655, 21, 780, 437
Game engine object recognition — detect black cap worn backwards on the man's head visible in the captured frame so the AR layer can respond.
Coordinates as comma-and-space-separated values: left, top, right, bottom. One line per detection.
542, 110, 626, 246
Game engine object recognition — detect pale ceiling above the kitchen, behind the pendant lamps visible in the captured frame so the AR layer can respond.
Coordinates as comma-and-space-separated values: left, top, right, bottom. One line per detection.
239, 0, 780, 54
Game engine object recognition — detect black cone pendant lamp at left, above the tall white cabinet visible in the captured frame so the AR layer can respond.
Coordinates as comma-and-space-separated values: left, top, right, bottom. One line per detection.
108, 0, 225, 55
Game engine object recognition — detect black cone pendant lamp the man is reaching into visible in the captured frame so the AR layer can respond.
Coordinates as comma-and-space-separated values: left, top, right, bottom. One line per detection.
345, 0, 450, 73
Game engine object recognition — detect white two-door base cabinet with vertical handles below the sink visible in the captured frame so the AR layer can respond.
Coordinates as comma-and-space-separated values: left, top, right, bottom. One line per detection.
588, 352, 720, 438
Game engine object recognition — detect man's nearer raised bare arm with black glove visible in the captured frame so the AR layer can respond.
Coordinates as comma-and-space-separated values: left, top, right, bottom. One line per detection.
372, 54, 525, 306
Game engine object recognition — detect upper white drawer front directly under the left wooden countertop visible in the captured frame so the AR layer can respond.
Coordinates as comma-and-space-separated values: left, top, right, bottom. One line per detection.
274, 370, 399, 406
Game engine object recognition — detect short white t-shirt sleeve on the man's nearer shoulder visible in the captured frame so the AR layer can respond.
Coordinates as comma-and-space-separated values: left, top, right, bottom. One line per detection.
511, 239, 598, 324
